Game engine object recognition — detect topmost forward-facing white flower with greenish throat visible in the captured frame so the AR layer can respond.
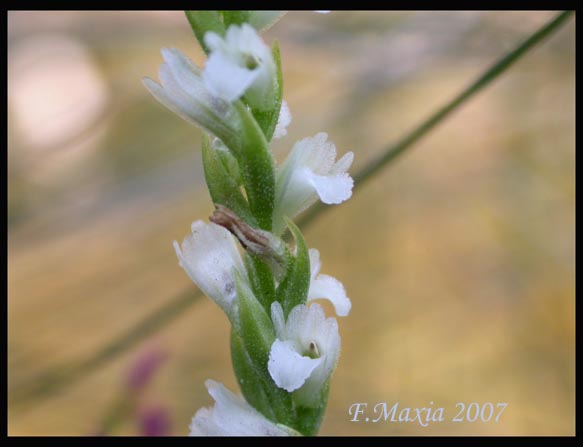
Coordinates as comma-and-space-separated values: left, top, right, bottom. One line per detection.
202, 23, 277, 107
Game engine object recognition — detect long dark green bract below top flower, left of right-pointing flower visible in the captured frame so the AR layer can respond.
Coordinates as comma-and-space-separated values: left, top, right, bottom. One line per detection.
230, 101, 275, 231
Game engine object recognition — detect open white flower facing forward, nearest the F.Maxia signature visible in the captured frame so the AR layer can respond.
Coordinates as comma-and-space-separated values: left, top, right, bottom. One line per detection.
267, 302, 340, 406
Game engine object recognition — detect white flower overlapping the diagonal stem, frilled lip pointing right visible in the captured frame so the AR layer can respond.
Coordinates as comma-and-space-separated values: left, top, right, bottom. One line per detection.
274, 132, 354, 234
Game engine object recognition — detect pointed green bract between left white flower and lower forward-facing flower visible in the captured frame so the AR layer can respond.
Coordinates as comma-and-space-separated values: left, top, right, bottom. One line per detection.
235, 272, 275, 370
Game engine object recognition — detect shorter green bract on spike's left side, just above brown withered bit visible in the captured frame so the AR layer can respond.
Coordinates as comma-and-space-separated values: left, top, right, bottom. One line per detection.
202, 135, 257, 225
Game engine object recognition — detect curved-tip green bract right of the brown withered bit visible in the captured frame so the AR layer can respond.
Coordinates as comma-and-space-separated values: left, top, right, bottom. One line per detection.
275, 219, 311, 318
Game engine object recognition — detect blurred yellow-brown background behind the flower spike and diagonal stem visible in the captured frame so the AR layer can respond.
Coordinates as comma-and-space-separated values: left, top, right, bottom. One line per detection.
8, 11, 575, 435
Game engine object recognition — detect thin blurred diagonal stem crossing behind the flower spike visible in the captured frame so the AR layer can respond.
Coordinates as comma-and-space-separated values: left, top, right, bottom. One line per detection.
9, 11, 573, 410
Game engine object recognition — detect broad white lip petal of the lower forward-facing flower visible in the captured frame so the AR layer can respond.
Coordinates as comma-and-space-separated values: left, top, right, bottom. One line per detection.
267, 340, 322, 393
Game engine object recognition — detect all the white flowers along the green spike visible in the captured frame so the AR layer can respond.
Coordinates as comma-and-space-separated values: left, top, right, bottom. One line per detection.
144, 24, 353, 435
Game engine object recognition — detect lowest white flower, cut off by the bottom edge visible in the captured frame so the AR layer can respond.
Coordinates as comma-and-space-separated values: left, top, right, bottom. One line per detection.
189, 380, 298, 436
